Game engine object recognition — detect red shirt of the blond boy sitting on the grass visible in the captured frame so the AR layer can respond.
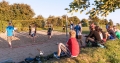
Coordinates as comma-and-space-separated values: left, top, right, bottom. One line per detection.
67, 38, 79, 56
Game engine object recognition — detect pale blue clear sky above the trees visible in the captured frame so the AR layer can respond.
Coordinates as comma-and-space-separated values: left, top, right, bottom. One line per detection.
0, 0, 120, 23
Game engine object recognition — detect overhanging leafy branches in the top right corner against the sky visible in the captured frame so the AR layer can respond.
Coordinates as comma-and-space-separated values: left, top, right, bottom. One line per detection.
69, 0, 120, 17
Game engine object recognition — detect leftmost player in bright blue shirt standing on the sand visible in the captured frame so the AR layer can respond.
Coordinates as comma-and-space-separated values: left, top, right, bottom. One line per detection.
6, 22, 14, 48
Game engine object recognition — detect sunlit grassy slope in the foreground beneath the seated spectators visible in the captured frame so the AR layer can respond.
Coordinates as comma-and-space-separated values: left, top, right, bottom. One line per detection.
44, 40, 120, 63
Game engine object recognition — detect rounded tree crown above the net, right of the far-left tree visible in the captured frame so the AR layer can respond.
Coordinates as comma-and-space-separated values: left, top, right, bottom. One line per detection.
11, 3, 35, 20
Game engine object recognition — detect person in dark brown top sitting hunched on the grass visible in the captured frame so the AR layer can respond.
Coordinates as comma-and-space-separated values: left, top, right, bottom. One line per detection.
86, 26, 104, 48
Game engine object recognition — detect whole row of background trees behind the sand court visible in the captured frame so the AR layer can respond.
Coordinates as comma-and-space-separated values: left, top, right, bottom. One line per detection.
0, 0, 119, 32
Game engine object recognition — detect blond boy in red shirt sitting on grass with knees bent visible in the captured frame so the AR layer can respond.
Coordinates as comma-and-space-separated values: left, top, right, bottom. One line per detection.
54, 30, 80, 59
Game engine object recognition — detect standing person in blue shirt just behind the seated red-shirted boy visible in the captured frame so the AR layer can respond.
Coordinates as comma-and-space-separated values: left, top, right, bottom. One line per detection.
74, 22, 83, 46
